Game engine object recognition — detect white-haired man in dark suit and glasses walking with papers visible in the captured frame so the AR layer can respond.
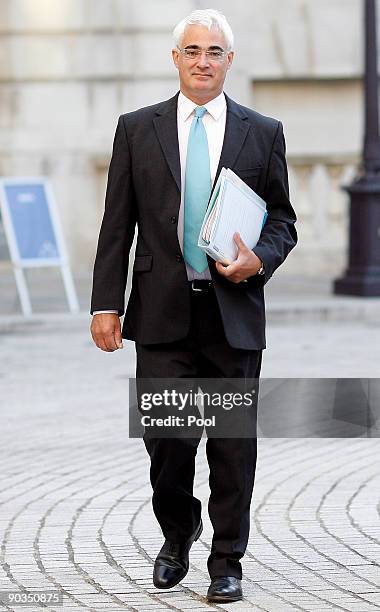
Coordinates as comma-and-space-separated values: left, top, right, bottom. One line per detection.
91, 10, 297, 602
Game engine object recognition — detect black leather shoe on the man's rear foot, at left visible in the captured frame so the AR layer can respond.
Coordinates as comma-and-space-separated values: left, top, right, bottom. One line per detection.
153, 520, 203, 589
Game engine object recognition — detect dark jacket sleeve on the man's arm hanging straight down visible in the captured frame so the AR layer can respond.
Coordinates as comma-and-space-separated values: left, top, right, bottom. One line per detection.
90, 116, 136, 316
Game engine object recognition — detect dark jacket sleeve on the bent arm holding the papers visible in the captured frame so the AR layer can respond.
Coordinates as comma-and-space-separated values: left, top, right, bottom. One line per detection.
253, 121, 297, 282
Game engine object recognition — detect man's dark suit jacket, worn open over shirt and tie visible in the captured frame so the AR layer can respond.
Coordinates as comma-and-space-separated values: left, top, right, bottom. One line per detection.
91, 93, 297, 349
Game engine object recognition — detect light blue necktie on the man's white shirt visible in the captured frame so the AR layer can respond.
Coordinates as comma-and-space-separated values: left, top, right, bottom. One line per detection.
183, 106, 211, 272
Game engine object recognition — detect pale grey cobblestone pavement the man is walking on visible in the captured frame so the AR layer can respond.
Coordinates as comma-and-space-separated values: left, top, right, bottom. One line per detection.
0, 316, 380, 612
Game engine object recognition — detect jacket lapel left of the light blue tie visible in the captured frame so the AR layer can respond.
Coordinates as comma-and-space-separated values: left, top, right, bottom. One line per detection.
153, 93, 181, 191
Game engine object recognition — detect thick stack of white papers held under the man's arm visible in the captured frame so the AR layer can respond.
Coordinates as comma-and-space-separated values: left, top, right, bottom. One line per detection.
198, 168, 267, 264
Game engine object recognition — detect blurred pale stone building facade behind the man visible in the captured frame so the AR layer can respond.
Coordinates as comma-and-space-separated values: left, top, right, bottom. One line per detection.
0, 0, 363, 277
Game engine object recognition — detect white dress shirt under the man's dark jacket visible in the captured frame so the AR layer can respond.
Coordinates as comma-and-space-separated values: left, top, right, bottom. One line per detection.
94, 92, 227, 315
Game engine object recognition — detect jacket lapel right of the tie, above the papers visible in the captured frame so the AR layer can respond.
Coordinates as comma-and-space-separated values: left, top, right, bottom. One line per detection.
213, 96, 250, 188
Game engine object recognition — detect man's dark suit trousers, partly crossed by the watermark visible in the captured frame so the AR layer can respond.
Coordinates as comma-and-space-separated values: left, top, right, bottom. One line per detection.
136, 288, 262, 578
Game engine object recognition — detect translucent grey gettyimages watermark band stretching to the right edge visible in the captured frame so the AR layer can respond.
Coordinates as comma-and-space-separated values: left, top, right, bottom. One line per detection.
129, 378, 380, 438
